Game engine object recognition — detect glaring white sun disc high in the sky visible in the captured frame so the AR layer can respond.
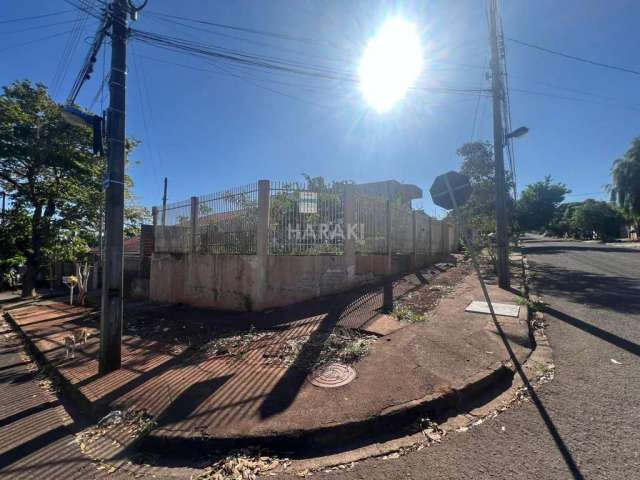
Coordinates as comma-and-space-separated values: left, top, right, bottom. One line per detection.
359, 18, 422, 112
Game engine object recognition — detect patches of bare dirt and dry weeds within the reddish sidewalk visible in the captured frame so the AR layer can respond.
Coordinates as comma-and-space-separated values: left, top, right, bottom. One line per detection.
114, 254, 472, 369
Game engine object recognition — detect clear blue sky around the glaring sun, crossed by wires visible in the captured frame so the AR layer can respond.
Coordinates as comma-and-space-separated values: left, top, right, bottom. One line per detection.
0, 0, 640, 218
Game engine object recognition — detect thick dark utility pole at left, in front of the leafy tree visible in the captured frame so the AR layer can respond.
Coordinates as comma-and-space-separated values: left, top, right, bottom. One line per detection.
99, 0, 128, 375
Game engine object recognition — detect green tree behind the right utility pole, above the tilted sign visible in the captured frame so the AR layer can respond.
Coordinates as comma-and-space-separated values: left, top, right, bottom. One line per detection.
457, 142, 514, 234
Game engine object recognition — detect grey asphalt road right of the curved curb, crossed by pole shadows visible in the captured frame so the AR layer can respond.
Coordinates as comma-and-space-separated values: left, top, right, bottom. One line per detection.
290, 239, 640, 480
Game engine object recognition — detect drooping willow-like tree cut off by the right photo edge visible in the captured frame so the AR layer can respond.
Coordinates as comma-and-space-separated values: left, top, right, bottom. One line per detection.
609, 137, 640, 232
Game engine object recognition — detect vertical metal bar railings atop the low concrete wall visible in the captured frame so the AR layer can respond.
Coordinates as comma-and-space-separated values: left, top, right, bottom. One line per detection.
154, 182, 455, 255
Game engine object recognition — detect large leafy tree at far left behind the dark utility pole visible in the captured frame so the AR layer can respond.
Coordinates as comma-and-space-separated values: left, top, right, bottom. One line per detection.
0, 80, 145, 296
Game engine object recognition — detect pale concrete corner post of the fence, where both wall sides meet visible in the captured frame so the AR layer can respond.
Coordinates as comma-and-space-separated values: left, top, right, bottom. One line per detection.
252, 180, 271, 310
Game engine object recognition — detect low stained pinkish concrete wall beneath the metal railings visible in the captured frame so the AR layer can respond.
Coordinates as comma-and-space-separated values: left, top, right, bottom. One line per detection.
149, 248, 456, 310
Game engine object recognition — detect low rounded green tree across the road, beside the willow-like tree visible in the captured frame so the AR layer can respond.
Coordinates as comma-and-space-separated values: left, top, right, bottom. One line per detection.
570, 199, 624, 241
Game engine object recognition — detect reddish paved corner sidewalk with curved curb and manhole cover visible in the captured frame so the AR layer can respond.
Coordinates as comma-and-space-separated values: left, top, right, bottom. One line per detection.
2, 258, 531, 458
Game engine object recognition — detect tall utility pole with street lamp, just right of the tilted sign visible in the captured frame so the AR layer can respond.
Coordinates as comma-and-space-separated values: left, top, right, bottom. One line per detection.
489, 0, 511, 288
